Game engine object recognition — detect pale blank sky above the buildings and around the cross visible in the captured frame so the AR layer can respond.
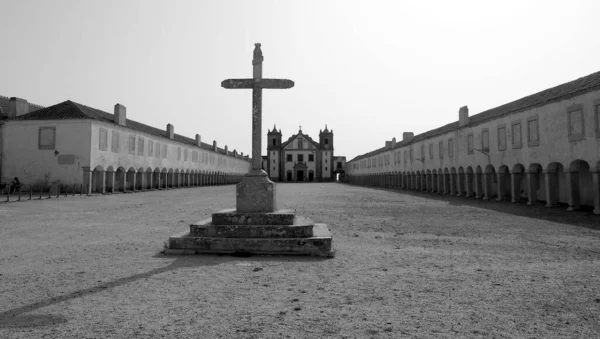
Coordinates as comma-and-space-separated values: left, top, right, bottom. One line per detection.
0, 0, 600, 160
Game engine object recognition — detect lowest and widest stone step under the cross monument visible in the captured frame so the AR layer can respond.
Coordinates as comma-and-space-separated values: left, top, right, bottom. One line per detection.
165, 224, 335, 257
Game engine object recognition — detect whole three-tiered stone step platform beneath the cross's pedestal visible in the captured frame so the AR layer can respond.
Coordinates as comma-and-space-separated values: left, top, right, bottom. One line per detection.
165, 209, 335, 257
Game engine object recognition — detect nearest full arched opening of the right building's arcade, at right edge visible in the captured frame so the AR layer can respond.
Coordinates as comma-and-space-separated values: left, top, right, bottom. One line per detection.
567, 159, 594, 211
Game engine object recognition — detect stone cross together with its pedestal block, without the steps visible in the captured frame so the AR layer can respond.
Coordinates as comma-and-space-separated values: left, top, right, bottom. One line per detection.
221, 44, 294, 213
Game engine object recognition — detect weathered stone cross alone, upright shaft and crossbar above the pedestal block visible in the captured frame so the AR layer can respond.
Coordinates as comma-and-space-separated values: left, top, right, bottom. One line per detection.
221, 43, 294, 176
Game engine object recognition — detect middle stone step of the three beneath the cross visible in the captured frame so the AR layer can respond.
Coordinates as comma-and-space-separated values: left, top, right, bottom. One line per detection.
190, 217, 314, 238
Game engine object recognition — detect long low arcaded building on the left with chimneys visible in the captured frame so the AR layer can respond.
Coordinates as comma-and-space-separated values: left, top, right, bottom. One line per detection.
0, 97, 251, 193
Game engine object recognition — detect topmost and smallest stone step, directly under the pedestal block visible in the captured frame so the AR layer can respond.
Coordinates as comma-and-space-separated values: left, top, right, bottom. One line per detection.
212, 208, 296, 225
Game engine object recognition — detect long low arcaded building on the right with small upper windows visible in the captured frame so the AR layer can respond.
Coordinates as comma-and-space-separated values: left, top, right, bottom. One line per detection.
347, 72, 600, 214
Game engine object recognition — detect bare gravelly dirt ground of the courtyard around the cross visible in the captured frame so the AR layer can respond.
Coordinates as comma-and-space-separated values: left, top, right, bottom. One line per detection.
0, 183, 600, 338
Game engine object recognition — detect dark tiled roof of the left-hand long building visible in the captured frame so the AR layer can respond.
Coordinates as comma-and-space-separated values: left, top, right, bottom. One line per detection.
8, 100, 245, 159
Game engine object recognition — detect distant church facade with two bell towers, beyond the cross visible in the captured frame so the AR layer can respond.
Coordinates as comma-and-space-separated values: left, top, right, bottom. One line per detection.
263, 126, 335, 182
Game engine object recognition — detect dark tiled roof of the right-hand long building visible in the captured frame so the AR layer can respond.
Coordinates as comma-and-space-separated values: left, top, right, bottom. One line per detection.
350, 72, 600, 161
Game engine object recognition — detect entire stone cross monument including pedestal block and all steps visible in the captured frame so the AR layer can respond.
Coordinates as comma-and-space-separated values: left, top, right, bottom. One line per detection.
165, 44, 335, 257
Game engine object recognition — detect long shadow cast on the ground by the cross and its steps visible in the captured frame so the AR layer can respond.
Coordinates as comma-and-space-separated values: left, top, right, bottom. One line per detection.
0, 253, 327, 329
